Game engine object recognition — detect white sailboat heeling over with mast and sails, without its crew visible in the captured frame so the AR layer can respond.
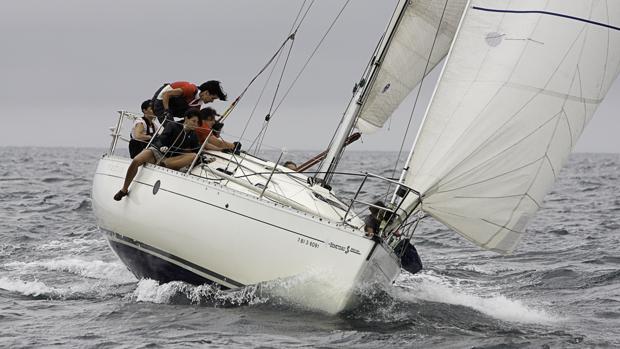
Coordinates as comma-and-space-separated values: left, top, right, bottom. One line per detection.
92, 0, 620, 313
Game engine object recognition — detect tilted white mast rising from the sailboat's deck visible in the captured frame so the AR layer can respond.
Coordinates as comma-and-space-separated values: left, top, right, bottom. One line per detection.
315, 0, 410, 186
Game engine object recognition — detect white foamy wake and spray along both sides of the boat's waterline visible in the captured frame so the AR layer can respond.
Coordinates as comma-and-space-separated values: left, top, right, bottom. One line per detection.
0, 253, 564, 324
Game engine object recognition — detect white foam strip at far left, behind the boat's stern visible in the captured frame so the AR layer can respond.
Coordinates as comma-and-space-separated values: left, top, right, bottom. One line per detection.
4, 258, 136, 283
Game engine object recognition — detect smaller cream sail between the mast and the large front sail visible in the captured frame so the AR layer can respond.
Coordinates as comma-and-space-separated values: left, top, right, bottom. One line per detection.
357, 0, 467, 132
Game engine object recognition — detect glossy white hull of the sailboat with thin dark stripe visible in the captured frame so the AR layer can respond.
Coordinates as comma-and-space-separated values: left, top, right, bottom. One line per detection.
92, 156, 400, 313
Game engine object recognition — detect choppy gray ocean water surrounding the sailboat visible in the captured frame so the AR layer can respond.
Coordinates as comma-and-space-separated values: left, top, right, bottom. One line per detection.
0, 148, 620, 348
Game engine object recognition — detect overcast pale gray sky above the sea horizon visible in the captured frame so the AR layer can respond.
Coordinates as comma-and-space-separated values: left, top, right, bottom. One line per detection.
0, 0, 620, 152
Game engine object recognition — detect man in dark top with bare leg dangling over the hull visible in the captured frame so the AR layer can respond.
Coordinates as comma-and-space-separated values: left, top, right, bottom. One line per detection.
114, 109, 200, 201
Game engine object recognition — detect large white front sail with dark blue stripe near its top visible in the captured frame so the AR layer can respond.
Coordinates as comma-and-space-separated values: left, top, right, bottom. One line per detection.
406, 0, 620, 252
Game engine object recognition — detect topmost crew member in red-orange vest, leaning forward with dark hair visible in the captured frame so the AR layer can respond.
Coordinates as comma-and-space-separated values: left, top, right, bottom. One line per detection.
153, 80, 226, 122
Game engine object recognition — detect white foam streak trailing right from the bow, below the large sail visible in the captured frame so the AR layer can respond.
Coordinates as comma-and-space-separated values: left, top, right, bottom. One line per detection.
395, 272, 561, 323
